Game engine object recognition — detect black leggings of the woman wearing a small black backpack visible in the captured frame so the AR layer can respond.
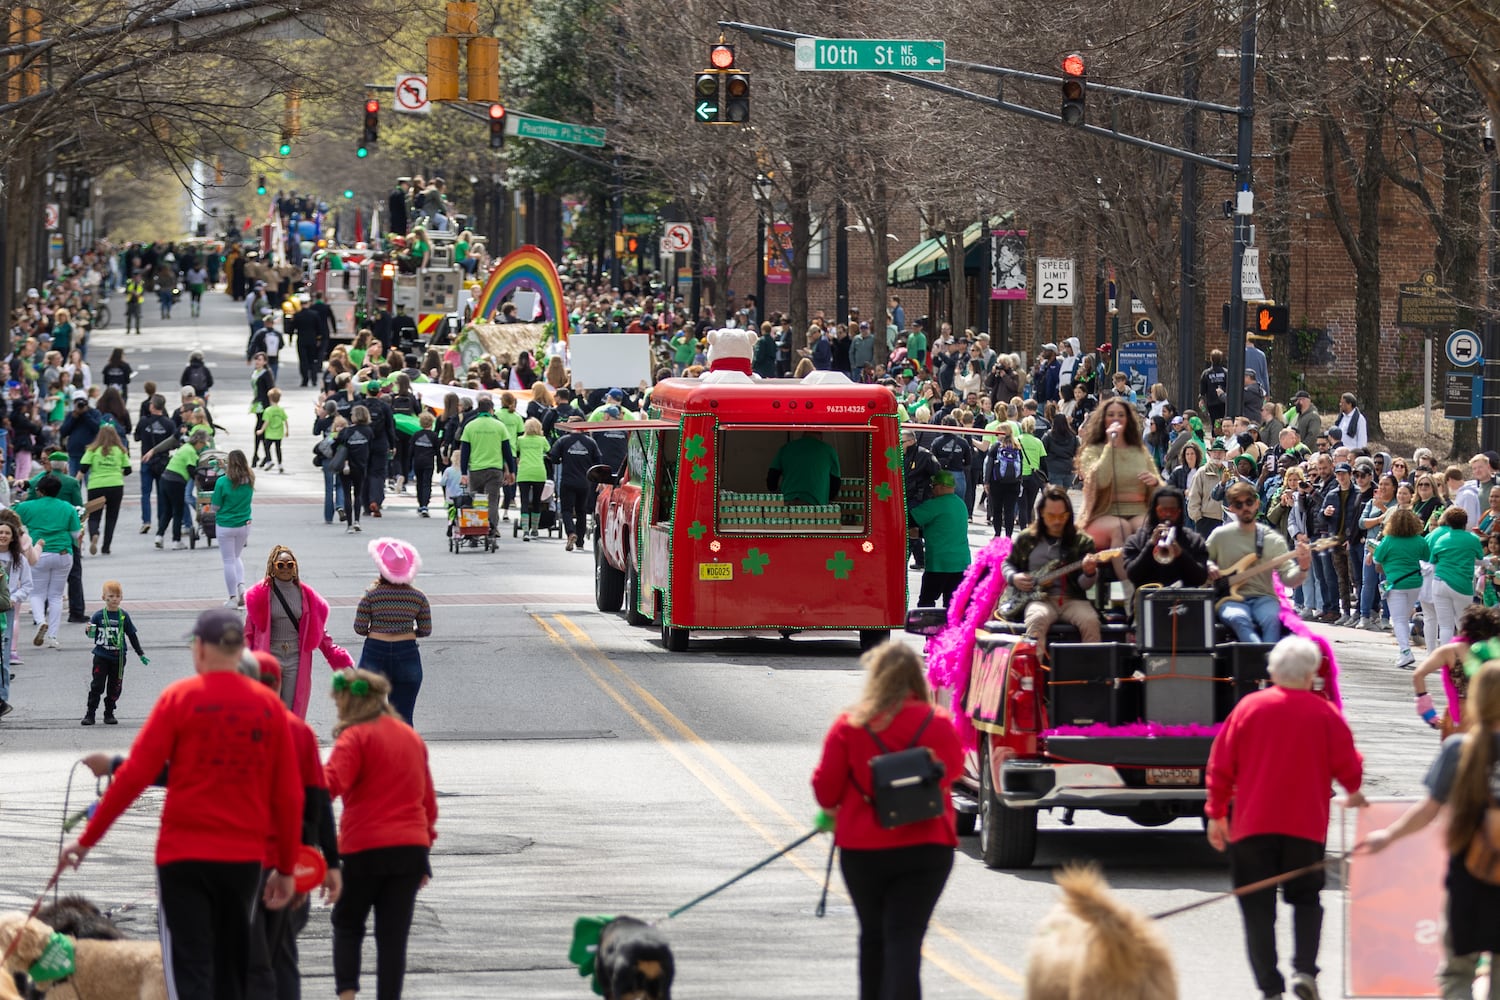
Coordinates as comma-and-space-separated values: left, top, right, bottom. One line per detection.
839, 844, 953, 1000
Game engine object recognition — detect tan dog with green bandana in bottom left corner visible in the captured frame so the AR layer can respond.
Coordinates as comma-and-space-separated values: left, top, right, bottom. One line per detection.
0, 913, 167, 1000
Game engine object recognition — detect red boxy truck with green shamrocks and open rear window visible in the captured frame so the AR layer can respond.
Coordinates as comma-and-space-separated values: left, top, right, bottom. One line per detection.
590, 372, 906, 652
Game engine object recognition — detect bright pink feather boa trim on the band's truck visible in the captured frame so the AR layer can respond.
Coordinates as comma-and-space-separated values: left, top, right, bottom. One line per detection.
927, 537, 1344, 748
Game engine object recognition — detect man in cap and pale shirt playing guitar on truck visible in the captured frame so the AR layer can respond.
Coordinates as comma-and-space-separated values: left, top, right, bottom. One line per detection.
1209, 483, 1313, 642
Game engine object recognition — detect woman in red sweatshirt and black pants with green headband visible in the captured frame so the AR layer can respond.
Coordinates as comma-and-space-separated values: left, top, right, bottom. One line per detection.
324, 670, 438, 1000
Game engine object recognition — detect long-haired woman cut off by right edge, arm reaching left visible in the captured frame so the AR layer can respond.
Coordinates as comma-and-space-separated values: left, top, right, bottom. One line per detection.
1365, 656, 1500, 1000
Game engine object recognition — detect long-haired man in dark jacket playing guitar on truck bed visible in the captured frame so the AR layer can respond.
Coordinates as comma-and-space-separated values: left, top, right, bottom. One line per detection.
1002, 486, 1100, 655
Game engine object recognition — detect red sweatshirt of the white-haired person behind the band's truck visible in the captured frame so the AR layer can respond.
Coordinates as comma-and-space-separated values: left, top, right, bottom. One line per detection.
1203, 687, 1364, 844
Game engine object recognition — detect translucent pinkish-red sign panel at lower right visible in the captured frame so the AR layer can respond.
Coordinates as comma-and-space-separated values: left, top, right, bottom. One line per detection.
1344, 803, 1448, 997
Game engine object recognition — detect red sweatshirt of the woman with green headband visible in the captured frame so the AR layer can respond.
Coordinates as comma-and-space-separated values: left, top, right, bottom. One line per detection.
324, 715, 438, 855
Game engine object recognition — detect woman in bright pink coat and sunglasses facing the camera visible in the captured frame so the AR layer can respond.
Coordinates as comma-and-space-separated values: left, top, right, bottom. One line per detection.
245, 546, 354, 718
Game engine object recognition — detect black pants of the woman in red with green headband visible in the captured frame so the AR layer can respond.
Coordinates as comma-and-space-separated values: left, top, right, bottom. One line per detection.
333, 847, 428, 1000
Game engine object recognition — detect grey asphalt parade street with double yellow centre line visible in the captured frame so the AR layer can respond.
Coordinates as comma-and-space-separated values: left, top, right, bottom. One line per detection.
0, 291, 1439, 1000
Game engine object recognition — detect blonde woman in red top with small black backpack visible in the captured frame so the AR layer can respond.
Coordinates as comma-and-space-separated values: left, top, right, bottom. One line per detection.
813, 642, 963, 1000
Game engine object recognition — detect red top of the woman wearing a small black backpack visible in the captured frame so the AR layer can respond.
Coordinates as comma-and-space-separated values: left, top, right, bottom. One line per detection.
813, 699, 963, 850
